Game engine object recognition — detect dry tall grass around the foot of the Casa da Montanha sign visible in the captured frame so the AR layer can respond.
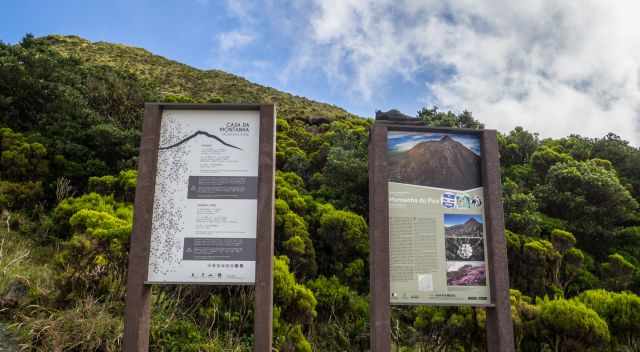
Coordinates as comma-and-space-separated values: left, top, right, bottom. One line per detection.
0, 229, 253, 352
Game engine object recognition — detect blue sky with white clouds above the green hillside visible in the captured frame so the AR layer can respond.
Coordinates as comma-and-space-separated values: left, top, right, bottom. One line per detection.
0, 0, 640, 146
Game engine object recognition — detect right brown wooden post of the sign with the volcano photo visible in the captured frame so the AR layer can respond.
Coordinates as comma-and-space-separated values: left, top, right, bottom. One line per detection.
480, 130, 515, 352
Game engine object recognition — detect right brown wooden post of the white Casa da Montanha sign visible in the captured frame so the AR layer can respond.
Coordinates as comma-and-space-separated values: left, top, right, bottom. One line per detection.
253, 105, 275, 352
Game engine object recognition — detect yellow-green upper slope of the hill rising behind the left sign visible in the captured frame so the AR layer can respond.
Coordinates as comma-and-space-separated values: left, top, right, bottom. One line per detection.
39, 35, 356, 119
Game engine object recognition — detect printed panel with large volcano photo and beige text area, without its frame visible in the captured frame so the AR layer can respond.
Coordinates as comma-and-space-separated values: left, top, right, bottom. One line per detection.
386, 130, 491, 305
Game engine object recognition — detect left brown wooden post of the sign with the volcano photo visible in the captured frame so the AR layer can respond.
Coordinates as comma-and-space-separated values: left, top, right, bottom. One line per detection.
369, 125, 391, 352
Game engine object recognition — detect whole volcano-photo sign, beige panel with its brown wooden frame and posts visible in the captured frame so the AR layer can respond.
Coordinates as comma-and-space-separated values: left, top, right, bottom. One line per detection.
369, 120, 514, 352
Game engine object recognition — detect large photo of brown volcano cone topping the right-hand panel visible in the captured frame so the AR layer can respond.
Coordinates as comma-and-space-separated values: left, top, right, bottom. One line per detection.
387, 131, 482, 190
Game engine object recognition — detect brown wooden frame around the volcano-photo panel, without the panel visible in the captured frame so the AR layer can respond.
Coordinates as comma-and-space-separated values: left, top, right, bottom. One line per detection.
369, 120, 515, 352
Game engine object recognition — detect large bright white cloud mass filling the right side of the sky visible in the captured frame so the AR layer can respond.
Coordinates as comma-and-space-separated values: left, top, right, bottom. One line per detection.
294, 0, 640, 145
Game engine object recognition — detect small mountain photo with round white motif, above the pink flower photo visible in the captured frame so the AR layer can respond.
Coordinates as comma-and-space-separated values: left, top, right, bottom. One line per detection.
444, 214, 484, 261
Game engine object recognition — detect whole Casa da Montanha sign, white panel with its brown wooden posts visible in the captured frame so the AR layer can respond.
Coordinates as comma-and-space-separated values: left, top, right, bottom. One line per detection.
124, 103, 275, 352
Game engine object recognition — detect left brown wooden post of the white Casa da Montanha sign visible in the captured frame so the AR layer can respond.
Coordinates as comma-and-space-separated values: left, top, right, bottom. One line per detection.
123, 104, 162, 352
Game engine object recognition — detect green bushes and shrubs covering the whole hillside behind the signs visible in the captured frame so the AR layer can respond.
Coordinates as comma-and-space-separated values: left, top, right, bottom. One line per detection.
0, 36, 640, 352
